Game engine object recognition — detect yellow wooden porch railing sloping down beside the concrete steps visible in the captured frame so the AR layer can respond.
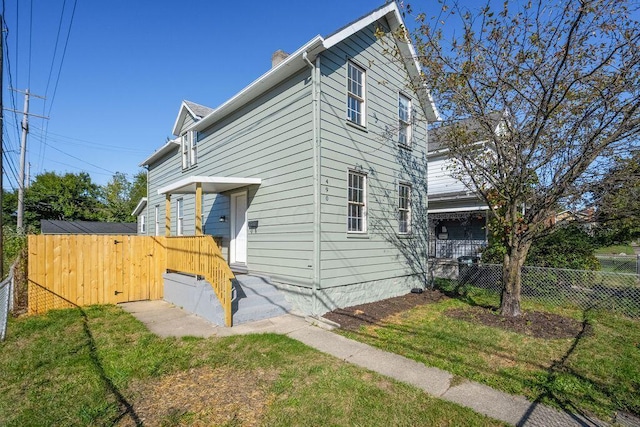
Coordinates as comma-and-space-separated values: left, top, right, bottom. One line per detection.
166, 236, 235, 326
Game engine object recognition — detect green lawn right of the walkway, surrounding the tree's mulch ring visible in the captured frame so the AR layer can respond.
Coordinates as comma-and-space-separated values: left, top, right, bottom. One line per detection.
344, 288, 640, 419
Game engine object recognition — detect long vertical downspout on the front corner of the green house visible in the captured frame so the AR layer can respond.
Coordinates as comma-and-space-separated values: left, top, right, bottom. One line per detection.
302, 51, 321, 316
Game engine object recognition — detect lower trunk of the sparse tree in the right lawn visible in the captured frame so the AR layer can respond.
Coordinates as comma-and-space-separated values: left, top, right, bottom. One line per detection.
500, 242, 531, 317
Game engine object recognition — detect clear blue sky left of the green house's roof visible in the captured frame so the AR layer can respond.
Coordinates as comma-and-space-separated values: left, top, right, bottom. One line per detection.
3, 0, 396, 190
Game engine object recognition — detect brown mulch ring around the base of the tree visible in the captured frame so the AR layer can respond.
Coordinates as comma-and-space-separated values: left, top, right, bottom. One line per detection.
445, 307, 589, 339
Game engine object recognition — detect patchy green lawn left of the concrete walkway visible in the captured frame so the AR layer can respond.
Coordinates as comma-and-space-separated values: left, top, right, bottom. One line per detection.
0, 306, 510, 426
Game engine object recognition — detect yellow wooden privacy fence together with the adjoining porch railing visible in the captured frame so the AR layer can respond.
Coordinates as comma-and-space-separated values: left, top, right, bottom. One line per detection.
28, 234, 234, 326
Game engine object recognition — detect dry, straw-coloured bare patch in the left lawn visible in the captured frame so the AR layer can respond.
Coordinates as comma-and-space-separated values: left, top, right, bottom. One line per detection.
118, 366, 277, 426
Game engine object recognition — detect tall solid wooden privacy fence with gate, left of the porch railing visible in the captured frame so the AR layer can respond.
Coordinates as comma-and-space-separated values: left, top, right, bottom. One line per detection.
28, 234, 167, 314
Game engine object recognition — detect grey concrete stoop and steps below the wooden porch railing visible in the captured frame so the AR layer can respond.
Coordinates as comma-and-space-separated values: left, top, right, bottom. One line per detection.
163, 273, 291, 326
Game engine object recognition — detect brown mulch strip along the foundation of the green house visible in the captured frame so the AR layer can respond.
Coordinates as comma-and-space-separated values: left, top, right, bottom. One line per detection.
322, 290, 448, 331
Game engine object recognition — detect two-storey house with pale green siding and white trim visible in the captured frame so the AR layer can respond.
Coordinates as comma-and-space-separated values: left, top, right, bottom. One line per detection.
137, 2, 438, 315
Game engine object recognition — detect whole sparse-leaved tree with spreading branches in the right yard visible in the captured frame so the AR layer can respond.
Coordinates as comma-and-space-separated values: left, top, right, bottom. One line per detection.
395, 0, 640, 316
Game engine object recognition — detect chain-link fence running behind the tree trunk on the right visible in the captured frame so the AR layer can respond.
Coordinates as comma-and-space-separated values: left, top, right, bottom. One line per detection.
434, 262, 640, 317
